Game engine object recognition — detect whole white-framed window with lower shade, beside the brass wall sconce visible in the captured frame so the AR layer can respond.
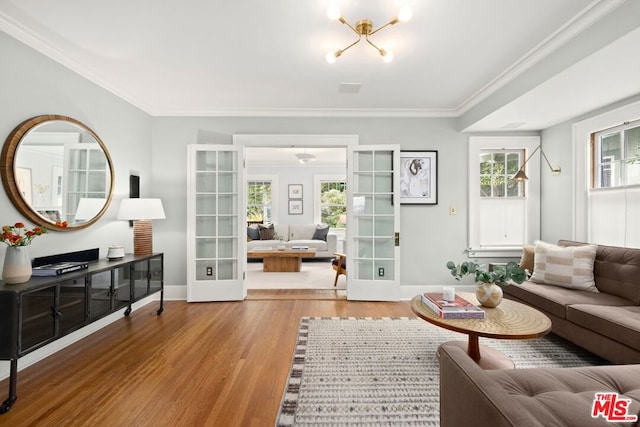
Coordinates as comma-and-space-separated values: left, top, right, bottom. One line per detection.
469, 136, 540, 257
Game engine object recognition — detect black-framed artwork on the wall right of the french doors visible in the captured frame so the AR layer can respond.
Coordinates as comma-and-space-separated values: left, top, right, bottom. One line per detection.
400, 151, 438, 205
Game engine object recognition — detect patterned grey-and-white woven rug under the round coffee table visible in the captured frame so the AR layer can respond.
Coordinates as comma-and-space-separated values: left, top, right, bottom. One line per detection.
276, 317, 607, 427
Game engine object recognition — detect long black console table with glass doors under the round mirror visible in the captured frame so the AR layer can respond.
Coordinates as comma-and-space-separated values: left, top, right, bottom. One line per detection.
0, 253, 164, 414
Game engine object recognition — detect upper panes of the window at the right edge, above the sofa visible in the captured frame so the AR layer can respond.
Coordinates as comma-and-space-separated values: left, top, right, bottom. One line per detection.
591, 120, 640, 188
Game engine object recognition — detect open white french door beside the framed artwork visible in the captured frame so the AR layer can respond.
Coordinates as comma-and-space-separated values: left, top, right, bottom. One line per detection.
347, 145, 400, 301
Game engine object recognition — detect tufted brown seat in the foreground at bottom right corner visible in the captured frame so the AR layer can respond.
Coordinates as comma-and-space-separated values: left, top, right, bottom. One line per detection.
438, 343, 640, 427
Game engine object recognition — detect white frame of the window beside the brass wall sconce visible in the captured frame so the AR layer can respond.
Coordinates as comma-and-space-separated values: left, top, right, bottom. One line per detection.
468, 136, 540, 258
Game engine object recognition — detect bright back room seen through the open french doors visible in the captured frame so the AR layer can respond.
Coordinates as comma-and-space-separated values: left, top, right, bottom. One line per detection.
246, 147, 347, 290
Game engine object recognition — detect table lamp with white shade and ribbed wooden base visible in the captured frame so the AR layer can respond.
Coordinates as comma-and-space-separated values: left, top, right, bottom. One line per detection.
117, 199, 166, 255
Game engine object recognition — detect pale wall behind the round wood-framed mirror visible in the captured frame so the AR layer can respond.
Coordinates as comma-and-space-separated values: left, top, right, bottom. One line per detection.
0, 32, 152, 265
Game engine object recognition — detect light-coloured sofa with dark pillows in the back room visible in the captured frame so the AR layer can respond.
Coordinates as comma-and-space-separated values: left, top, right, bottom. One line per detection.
247, 224, 338, 258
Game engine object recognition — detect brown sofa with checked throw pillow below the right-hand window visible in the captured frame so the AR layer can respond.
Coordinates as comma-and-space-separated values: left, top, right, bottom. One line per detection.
503, 240, 640, 364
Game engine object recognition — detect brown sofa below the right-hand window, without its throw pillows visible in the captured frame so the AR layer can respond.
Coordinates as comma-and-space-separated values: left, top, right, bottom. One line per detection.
503, 240, 640, 364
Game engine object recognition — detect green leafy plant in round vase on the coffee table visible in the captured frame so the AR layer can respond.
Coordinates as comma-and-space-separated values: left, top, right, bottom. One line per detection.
447, 261, 530, 307
